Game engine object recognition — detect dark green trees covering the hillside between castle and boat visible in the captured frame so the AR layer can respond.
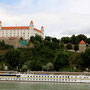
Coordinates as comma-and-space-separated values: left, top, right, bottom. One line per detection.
0, 35, 90, 71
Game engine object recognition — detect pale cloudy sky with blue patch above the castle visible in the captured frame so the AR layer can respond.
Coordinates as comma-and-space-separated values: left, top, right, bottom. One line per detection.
0, 0, 90, 38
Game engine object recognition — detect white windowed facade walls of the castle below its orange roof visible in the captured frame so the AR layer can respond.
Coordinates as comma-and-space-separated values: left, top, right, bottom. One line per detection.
0, 29, 43, 39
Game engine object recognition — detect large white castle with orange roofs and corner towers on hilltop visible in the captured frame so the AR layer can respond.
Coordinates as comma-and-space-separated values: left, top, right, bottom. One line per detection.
0, 21, 44, 39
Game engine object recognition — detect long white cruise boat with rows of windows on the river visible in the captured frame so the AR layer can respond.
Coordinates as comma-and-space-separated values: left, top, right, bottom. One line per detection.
0, 72, 90, 83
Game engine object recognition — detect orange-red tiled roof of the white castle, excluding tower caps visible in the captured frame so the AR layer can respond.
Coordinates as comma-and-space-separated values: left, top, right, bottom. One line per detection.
1, 26, 42, 33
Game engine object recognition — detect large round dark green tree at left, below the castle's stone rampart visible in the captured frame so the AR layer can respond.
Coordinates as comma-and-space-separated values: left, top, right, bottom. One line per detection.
5, 49, 24, 70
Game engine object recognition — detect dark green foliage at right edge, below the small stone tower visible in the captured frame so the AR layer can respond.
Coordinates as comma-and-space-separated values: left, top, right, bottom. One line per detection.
73, 48, 90, 71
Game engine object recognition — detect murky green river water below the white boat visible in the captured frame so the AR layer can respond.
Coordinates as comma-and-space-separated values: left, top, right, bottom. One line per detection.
0, 82, 90, 90
